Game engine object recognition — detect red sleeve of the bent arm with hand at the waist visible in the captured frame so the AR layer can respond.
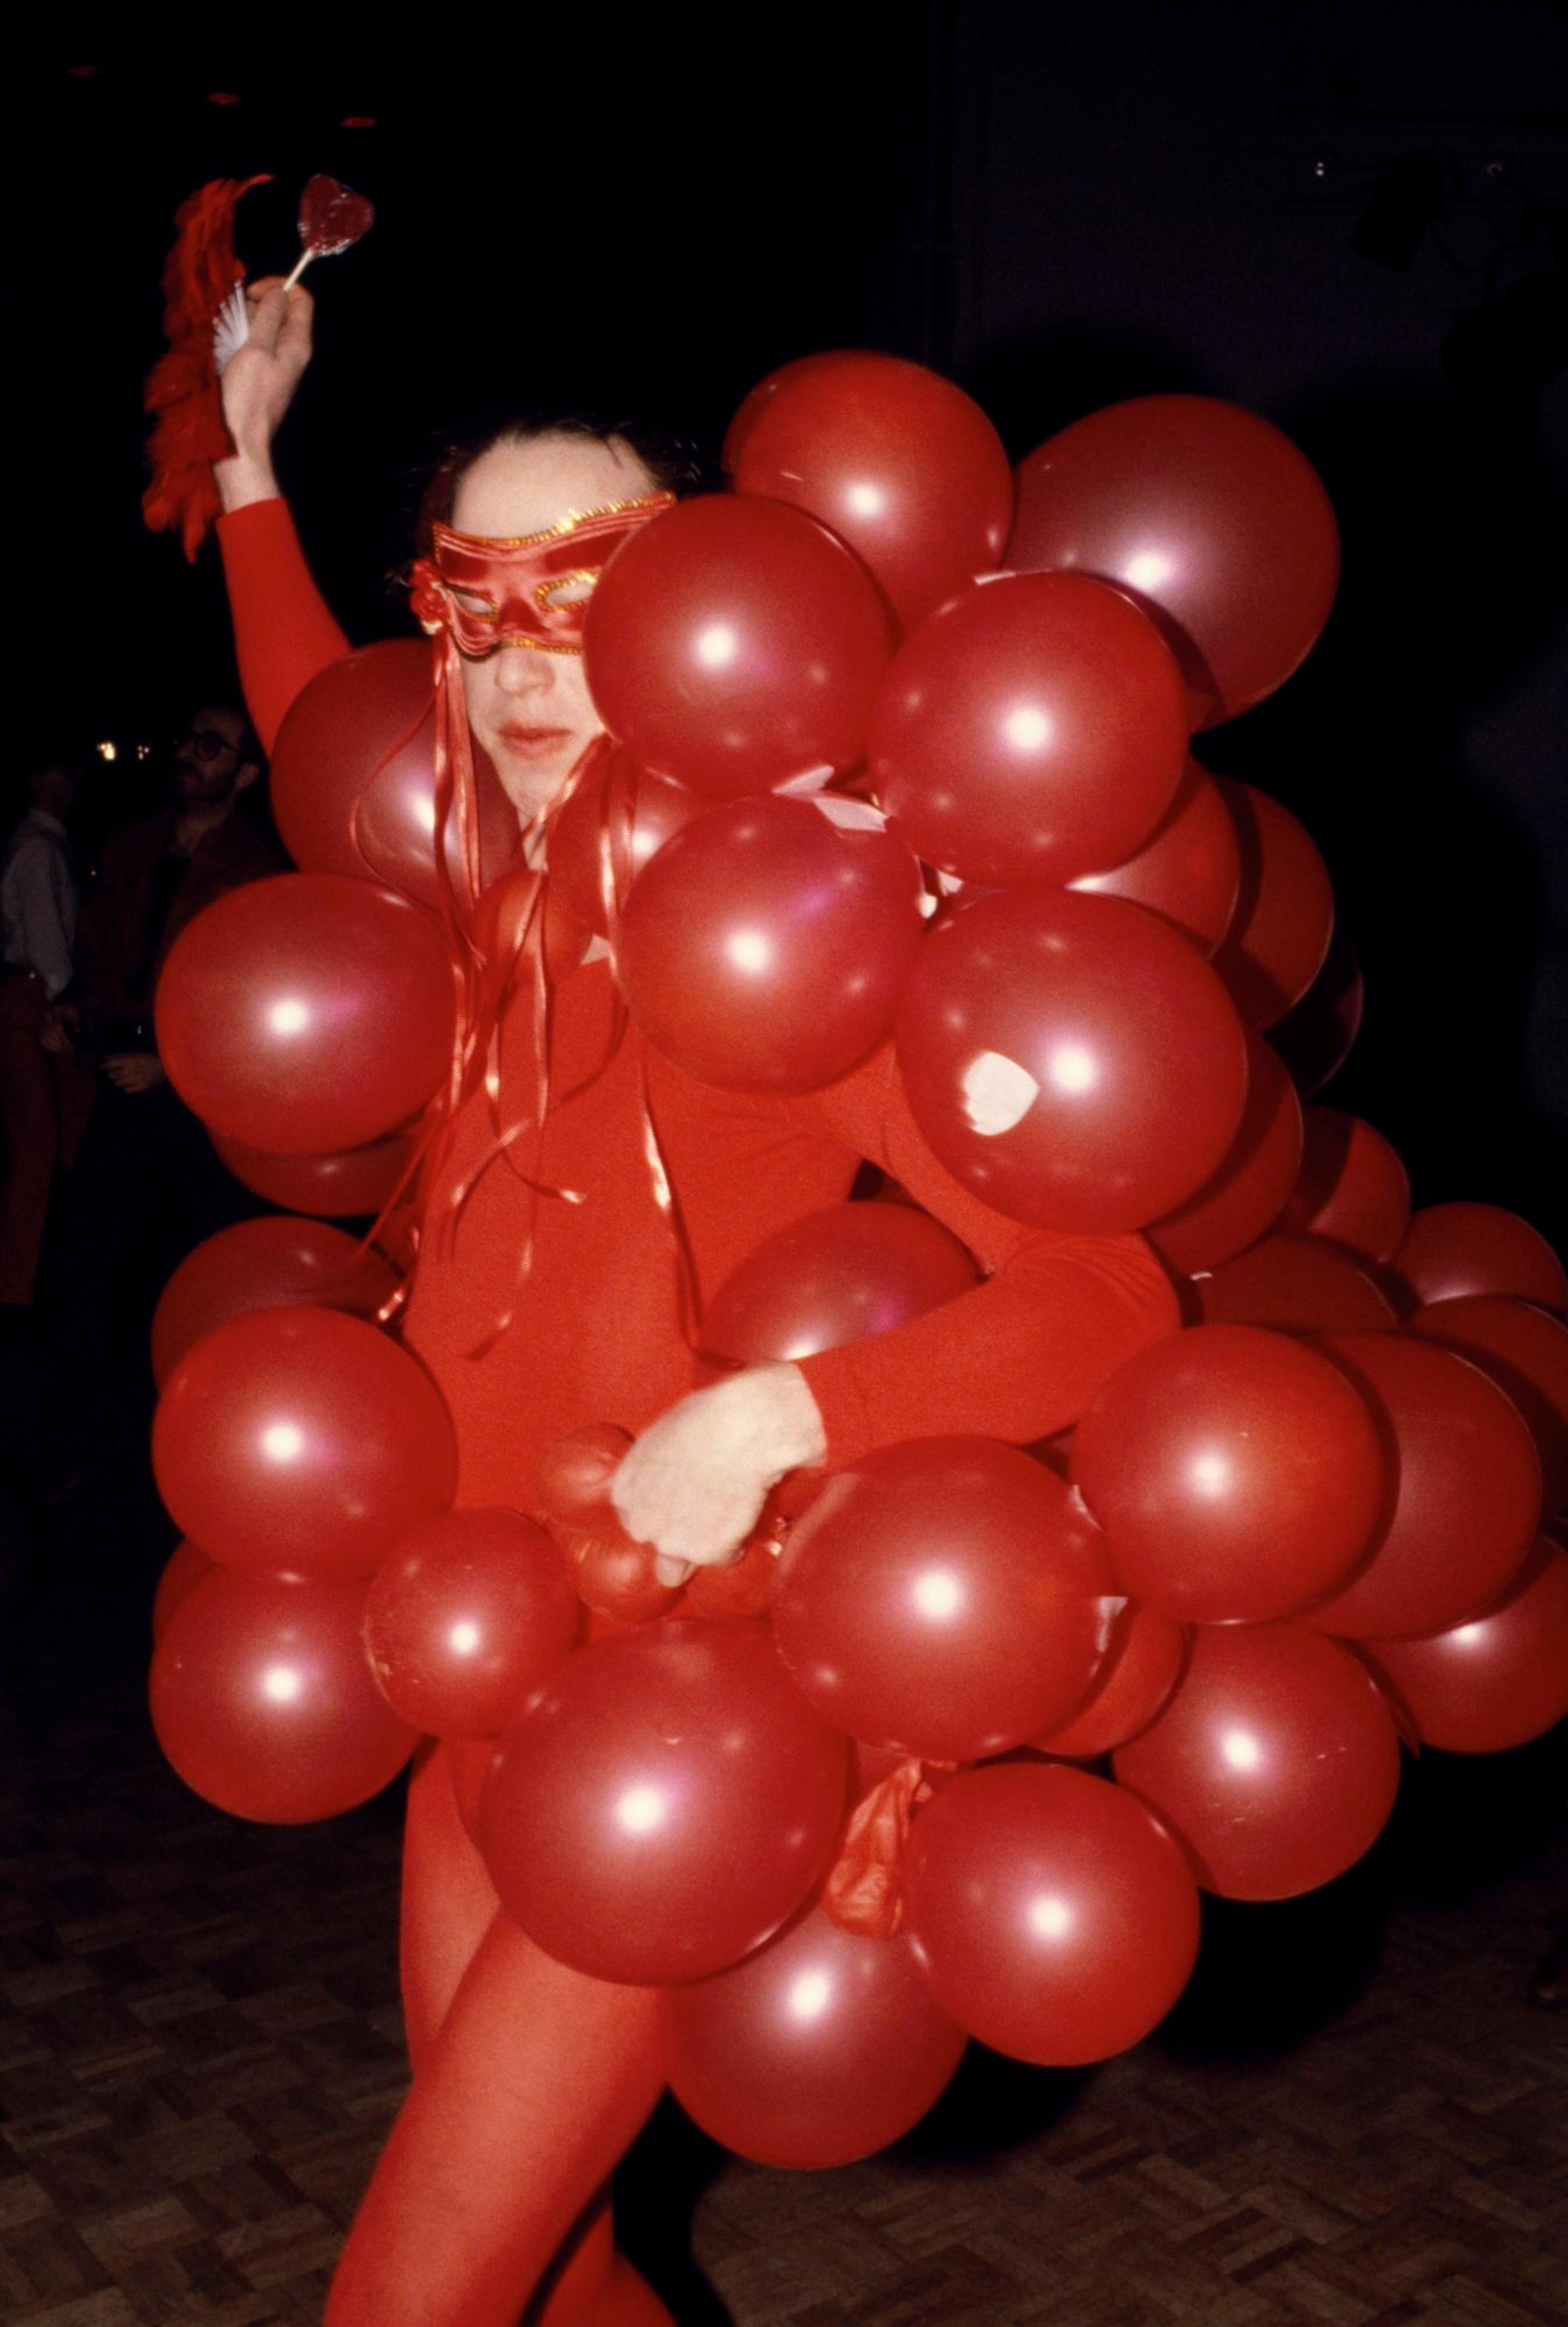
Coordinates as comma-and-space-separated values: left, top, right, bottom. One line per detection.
782, 1045, 1182, 1466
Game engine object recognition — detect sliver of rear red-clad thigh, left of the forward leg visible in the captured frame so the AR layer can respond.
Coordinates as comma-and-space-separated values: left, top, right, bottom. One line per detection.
398, 1740, 500, 2076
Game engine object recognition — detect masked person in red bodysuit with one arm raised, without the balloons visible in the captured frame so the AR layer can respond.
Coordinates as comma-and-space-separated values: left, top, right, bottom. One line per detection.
219, 288, 1177, 2327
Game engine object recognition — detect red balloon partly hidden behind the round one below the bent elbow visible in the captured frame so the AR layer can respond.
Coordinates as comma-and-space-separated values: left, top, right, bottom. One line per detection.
1303, 1333, 1540, 1640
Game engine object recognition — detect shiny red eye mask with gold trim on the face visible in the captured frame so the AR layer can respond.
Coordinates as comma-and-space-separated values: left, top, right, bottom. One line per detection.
412, 493, 675, 656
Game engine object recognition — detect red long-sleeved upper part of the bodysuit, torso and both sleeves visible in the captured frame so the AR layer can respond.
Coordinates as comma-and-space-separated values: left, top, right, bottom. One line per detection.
219, 500, 1180, 1506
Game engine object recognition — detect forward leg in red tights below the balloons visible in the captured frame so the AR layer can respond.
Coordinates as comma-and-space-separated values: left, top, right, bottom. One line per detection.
326, 1915, 668, 2327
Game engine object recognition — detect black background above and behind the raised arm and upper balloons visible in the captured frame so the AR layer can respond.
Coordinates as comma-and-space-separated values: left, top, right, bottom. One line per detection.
7, 0, 1568, 1245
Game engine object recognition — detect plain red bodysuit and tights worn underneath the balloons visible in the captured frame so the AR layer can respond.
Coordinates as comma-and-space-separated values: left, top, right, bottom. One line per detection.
221, 500, 1180, 2327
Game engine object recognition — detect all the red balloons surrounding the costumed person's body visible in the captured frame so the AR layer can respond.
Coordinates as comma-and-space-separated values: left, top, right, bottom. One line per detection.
140, 354, 1568, 2166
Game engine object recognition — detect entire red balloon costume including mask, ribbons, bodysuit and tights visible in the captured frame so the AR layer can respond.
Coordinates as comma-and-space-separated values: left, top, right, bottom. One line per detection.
137, 291, 1568, 2327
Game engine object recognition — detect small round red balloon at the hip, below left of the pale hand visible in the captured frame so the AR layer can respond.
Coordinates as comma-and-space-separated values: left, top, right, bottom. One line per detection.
365, 1510, 581, 1738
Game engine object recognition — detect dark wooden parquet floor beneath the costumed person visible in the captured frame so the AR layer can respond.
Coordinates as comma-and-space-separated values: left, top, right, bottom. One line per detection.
0, 1470, 1568, 2327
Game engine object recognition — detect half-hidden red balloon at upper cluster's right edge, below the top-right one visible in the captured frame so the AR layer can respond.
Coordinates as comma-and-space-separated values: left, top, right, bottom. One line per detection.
1214, 777, 1333, 1026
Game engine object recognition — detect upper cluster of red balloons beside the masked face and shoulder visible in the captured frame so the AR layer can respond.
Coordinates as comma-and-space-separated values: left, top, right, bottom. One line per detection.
575, 354, 1338, 1219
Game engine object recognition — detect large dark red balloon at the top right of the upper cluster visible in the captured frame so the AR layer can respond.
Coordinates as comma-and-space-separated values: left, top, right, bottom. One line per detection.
1007, 395, 1340, 726
